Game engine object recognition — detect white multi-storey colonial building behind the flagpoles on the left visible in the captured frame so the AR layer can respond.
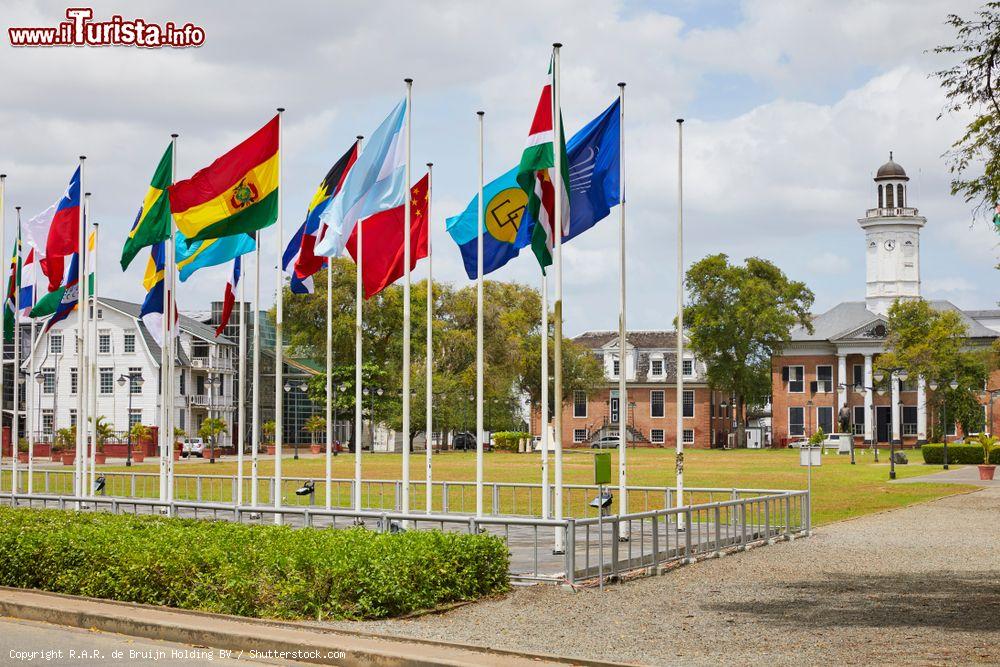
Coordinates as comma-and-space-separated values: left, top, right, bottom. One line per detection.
17, 297, 237, 447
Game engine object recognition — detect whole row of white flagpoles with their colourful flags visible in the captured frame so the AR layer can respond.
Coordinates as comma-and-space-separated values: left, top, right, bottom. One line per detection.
0, 44, 683, 536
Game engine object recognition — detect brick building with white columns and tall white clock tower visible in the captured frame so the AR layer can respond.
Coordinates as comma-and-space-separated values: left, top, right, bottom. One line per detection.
771, 154, 1000, 446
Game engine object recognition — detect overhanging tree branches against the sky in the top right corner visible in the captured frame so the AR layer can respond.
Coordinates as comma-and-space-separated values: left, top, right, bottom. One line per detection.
934, 2, 1000, 232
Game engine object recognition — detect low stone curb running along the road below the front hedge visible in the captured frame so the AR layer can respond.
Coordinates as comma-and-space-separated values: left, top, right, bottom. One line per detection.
0, 587, 621, 667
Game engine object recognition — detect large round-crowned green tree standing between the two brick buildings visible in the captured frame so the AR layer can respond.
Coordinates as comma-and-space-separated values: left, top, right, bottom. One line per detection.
684, 254, 815, 446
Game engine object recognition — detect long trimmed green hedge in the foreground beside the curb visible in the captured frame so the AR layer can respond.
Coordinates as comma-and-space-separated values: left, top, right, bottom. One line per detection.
0, 508, 509, 619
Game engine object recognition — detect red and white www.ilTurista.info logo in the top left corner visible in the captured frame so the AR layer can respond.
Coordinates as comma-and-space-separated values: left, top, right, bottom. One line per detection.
7, 7, 205, 49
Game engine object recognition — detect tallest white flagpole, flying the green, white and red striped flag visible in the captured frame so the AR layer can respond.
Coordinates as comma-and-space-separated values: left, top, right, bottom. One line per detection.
552, 42, 568, 554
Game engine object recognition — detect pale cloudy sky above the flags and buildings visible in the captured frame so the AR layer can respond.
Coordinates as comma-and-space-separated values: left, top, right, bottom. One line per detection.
0, 0, 1000, 335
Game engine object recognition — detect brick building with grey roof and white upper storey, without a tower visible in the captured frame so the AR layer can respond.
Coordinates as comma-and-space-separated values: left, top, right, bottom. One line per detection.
531, 331, 732, 448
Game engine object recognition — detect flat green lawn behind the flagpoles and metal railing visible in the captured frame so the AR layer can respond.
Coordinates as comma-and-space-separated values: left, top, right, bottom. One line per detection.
47, 449, 969, 525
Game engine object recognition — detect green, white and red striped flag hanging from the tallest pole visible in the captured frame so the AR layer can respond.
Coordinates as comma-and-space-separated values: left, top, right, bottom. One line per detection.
517, 61, 570, 271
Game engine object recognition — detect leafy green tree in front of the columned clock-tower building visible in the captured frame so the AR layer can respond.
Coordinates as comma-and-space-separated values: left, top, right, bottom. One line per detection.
875, 299, 991, 439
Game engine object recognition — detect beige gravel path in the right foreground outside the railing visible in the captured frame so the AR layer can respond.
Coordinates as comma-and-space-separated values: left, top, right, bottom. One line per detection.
326, 487, 1000, 665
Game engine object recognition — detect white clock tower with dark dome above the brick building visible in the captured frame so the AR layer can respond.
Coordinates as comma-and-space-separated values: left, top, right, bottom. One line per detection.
858, 152, 927, 315
